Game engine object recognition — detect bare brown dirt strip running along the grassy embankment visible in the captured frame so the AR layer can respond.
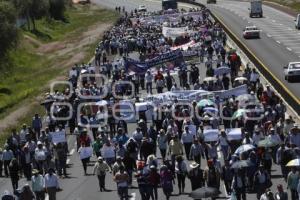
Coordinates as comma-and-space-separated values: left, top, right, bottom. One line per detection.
0, 23, 112, 133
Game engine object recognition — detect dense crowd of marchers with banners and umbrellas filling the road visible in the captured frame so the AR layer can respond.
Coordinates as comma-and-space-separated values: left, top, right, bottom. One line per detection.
0, 4, 300, 200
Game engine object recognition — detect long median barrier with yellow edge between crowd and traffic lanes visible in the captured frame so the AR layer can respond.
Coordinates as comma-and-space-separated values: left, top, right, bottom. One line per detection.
177, 0, 300, 116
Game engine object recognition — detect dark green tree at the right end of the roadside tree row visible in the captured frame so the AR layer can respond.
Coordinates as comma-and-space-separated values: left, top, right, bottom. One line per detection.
49, 0, 67, 20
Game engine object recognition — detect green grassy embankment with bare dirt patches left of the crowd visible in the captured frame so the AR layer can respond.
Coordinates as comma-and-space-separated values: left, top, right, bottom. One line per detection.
0, 5, 119, 146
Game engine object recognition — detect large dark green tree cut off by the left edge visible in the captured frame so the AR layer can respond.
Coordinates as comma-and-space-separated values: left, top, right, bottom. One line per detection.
0, 1, 18, 59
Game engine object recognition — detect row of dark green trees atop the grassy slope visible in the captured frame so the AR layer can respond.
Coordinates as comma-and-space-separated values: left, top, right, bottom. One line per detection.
0, 0, 70, 60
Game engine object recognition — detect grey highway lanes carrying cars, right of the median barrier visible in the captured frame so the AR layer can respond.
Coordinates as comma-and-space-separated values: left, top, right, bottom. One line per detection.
202, 0, 300, 109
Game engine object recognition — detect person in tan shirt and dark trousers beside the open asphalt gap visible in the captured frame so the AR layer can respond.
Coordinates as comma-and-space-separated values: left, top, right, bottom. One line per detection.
93, 156, 111, 192
